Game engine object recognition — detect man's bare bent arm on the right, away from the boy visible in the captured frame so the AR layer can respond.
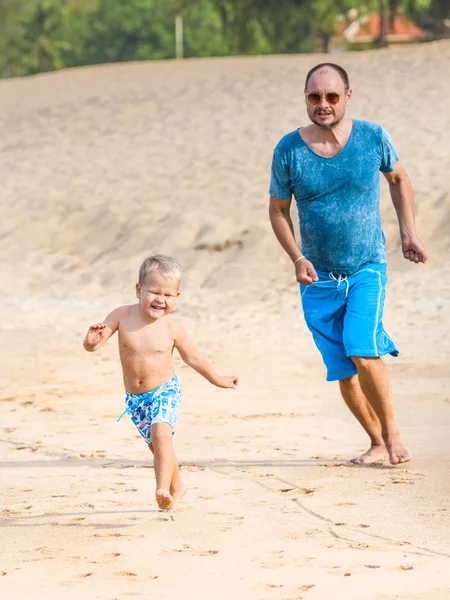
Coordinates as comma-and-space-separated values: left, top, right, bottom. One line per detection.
383, 161, 428, 263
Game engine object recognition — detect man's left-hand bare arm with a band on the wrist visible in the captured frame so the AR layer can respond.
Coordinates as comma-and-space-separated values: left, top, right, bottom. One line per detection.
269, 196, 318, 285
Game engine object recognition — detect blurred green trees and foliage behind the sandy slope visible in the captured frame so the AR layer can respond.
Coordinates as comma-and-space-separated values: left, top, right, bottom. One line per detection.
0, 0, 449, 77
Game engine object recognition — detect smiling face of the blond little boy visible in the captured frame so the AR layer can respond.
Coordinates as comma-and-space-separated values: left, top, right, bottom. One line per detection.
136, 270, 180, 320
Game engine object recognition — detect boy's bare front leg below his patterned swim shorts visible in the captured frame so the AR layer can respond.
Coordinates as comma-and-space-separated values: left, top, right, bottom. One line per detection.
151, 423, 176, 510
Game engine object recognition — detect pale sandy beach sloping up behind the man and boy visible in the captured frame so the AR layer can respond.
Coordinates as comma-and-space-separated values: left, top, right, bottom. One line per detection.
0, 41, 450, 600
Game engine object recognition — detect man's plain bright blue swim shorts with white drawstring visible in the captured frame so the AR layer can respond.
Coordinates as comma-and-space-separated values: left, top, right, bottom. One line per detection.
300, 263, 398, 381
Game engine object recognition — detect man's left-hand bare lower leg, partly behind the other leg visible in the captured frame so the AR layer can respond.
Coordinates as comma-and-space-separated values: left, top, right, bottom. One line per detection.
339, 375, 388, 465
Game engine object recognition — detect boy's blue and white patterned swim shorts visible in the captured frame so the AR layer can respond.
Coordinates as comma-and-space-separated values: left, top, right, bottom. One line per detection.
117, 376, 181, 444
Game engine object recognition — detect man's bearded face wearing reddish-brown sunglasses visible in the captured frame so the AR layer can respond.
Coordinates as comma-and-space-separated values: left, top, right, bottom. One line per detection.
305, 67, 352, 130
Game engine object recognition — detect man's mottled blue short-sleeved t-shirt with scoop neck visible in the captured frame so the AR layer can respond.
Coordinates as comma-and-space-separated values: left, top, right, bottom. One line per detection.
269, 120, 398, 274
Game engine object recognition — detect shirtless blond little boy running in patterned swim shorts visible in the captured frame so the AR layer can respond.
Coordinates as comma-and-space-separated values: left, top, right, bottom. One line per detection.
83, 254, 239, 512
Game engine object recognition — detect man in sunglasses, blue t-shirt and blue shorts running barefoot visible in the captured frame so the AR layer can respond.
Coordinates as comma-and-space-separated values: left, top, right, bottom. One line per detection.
269, 63, 427, 465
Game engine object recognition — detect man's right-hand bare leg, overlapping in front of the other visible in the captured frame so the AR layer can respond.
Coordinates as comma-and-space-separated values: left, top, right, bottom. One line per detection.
350, 356, 411, 465
